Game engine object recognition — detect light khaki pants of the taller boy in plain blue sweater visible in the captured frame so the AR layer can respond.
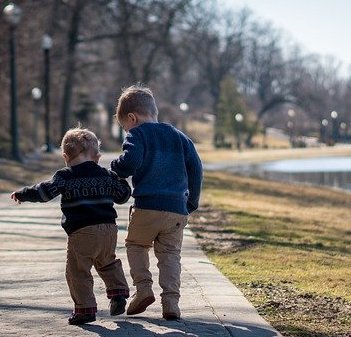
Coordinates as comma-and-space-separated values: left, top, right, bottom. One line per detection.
126, 208, 188, 303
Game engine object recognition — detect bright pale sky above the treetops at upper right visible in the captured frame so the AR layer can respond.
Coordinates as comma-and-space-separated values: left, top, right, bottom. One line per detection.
220, 0, 351, 72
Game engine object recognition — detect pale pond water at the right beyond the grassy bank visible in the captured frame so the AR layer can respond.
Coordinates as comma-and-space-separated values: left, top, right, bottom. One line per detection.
258, 157, 351, 190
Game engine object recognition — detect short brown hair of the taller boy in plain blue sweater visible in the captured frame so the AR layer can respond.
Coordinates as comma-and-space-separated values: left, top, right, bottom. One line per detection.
115, 84, 158, 120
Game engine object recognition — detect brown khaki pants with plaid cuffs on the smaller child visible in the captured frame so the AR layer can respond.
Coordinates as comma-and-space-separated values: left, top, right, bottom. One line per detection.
66, 224, 129, 313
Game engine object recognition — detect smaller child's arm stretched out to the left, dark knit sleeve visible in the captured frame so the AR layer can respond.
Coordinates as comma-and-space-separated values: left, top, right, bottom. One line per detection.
11, 173, 64, 202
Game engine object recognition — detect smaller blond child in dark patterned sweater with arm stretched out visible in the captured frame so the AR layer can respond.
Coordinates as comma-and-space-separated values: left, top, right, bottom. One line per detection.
11, 128, 131, 325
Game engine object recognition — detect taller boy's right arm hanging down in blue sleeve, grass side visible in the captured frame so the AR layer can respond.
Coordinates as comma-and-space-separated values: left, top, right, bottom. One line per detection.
186, 140, 203, 214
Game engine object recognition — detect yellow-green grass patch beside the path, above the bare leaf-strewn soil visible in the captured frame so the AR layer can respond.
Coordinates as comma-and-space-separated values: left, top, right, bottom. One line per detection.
209, 244, 351, 301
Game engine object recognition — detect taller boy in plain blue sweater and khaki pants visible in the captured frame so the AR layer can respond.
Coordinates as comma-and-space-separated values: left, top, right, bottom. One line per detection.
111, 85, 202, 320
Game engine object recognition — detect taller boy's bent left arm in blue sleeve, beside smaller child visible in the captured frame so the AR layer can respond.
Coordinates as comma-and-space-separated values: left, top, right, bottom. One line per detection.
111, 130, 144, 178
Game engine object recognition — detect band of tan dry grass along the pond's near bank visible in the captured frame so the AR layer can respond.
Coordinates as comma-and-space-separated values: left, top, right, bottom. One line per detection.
206, 173, 351, 229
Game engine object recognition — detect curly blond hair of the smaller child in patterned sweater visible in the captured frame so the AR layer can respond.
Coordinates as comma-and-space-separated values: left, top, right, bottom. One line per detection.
61, 126, 101, 160
